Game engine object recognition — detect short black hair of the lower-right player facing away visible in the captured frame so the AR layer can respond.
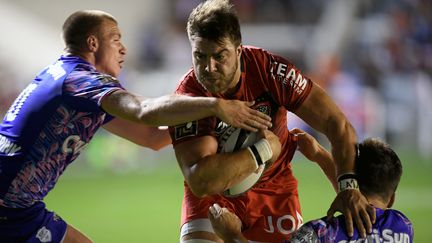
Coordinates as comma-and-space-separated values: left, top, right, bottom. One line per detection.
355, 138, 402, 200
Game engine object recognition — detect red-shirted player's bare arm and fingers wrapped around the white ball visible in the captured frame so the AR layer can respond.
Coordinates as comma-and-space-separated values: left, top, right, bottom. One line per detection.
175, 130, 281, 197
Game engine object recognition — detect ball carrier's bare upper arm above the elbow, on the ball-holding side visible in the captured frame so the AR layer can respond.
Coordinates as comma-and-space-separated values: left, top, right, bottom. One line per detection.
174, 136, 218, 178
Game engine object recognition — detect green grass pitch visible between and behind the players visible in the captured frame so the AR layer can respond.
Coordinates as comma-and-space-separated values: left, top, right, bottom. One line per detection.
46, 153, 432, 243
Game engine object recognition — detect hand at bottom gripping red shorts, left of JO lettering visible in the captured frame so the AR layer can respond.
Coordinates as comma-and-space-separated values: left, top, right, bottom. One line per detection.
208, 203, 242, 241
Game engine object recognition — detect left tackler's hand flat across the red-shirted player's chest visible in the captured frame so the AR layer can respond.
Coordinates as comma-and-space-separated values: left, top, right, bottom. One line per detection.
217, 99, 272, 132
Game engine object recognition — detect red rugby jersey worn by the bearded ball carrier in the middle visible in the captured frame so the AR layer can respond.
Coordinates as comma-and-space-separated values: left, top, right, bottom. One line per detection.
170, 46, 313, 181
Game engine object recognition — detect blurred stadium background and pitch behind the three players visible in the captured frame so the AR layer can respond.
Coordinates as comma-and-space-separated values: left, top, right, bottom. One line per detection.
0, 0, 432, 242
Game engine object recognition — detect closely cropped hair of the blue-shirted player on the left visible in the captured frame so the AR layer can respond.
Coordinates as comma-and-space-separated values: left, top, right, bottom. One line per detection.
62, 10, 117, 53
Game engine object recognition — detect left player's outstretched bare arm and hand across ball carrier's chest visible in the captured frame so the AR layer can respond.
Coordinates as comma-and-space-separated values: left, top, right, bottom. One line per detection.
102, 90, 271, 131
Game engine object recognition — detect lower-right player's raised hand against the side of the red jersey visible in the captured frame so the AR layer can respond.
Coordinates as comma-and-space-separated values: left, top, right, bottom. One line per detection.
290, 128, 320, 161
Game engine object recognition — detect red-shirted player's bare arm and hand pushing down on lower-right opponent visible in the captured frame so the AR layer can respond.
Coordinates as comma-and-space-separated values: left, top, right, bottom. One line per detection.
295, 84, 375, 236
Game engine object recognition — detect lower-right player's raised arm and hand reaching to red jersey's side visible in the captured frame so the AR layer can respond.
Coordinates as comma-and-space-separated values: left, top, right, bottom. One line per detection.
290, 128, 338, 193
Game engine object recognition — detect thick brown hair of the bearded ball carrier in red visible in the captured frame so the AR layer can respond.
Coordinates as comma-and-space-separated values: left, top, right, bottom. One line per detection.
186, 0, 241, 46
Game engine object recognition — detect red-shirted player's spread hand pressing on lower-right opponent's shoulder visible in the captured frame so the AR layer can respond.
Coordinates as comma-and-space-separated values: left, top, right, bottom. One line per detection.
327, 189, 376, 238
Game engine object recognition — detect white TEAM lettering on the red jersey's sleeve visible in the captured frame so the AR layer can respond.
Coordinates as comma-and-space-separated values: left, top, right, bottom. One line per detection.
270, 62, 308, 94
